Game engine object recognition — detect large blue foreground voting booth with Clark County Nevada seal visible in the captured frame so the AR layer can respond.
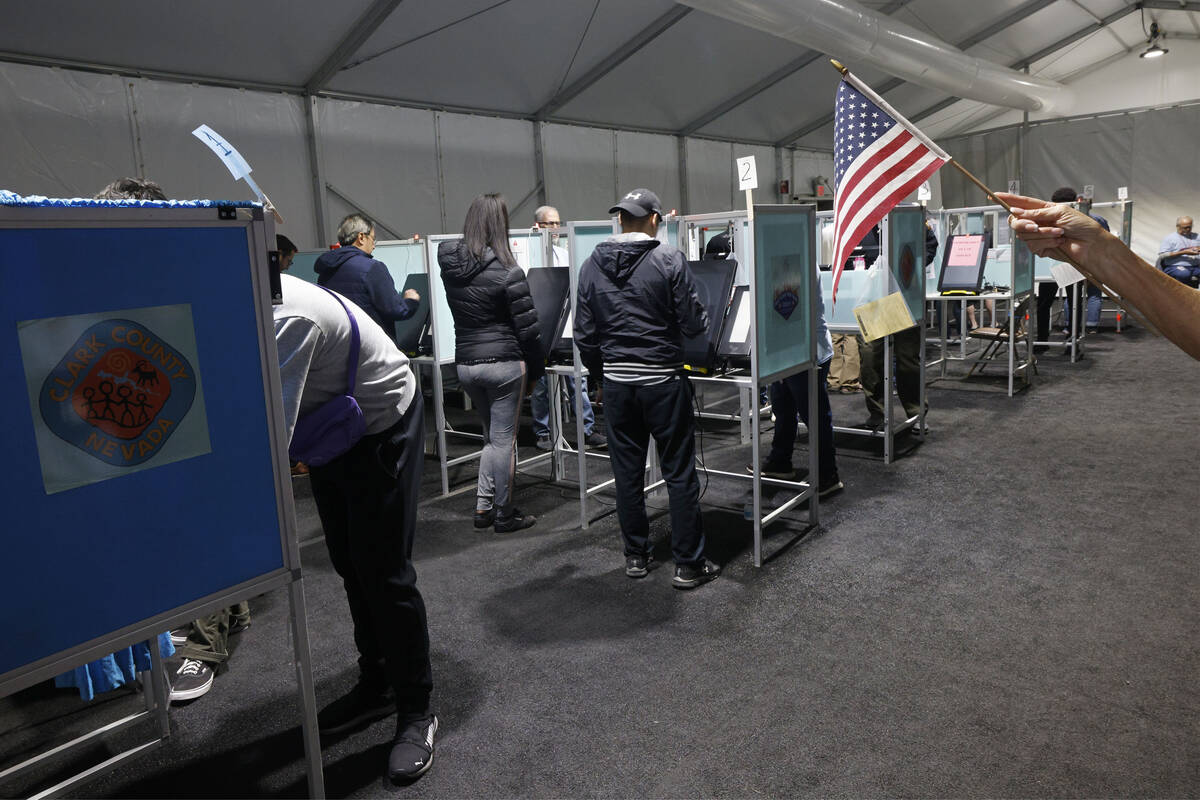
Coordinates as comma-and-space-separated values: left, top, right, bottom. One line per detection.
0, 193, 324, 796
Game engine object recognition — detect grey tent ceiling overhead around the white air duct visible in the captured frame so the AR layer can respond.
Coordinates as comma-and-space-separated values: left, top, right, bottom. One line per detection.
0, 0, 1200, 150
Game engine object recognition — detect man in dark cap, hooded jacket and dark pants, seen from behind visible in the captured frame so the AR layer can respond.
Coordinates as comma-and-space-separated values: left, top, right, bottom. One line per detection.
575, 188, 721, 589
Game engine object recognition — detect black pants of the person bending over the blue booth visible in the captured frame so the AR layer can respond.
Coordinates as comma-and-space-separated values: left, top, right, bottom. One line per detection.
310, 396, 433, 716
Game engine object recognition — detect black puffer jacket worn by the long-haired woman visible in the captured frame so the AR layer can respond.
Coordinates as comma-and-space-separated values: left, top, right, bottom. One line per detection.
438, 240, 546, 383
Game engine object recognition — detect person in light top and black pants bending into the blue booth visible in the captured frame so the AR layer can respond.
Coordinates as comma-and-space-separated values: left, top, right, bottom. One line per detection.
274, 275, 438, 783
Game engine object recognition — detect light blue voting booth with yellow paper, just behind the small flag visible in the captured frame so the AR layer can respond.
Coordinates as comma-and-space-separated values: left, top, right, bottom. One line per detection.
809, 205, 925, 464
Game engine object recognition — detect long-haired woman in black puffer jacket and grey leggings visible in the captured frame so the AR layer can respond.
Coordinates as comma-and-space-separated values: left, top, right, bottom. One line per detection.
438, 194, 546, 533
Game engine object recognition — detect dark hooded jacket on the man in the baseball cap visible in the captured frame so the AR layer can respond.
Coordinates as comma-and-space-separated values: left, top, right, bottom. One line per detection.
575, 234, 708, 378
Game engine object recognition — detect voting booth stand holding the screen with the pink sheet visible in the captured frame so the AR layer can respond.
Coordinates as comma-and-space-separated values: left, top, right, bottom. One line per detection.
926, 225, 1036, 397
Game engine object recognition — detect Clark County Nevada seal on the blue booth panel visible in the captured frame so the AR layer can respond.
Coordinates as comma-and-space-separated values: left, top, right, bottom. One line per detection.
38, 319, 196, 467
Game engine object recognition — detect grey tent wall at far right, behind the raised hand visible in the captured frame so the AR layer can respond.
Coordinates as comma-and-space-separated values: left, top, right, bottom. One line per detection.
940, 106, 1200, 263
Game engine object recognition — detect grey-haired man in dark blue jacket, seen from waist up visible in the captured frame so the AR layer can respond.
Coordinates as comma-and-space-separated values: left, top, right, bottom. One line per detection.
313, 213, 421, 342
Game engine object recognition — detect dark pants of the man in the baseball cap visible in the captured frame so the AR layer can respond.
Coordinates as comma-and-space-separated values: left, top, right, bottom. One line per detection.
604, 378, 704, 565
